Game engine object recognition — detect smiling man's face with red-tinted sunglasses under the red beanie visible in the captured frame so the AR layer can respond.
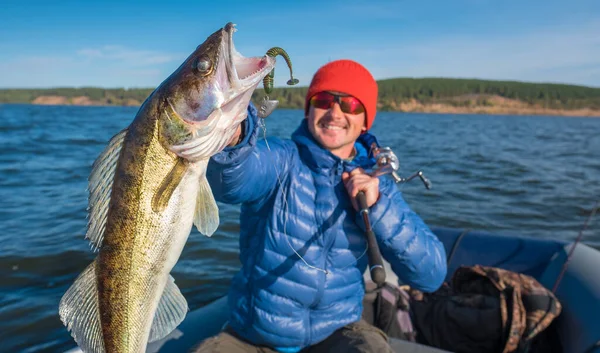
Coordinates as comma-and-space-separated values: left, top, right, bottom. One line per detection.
306, 92, 366, 158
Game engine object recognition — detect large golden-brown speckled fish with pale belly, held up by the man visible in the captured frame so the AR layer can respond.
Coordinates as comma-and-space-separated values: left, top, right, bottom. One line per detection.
59, 23, 275, 353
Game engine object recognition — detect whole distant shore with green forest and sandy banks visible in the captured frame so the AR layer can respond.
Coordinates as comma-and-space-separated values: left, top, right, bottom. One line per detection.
0, 77, 600, 117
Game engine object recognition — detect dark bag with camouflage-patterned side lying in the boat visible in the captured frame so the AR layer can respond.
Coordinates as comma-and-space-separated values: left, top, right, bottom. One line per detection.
409, 265, 561, 353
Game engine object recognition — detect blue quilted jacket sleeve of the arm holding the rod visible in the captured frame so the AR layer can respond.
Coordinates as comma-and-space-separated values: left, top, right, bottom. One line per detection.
359, 177, 447, 292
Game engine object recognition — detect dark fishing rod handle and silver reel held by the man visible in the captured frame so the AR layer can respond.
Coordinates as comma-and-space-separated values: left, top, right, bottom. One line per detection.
356, 146, 431, 287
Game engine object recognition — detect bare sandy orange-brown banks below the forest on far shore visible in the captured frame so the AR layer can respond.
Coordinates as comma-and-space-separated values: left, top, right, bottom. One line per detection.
26, 96, 600, 118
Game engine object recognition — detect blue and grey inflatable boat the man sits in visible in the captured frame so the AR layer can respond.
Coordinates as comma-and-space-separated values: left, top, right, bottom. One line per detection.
63, 228, 600, 353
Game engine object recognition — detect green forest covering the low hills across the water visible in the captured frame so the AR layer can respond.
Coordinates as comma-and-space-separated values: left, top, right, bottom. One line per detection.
0, 78, 600, 110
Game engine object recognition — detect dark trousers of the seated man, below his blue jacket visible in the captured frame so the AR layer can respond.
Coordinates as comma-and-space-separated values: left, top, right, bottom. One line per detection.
192, 320, 393, 353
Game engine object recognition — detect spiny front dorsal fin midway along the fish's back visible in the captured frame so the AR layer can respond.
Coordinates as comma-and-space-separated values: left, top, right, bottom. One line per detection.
85, 129, 127, 251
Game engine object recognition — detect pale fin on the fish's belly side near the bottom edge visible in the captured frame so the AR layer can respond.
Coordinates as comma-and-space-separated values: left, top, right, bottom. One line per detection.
148, 276, 188, 343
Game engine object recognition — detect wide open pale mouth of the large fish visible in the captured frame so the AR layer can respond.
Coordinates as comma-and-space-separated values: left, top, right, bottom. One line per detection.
223, 23, 275, 93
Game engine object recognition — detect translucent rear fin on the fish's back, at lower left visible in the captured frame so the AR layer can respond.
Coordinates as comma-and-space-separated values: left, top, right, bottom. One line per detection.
58, 261, 104, 352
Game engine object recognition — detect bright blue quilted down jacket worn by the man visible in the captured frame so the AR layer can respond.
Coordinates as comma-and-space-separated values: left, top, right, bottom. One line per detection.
207, 105, 446, 351
